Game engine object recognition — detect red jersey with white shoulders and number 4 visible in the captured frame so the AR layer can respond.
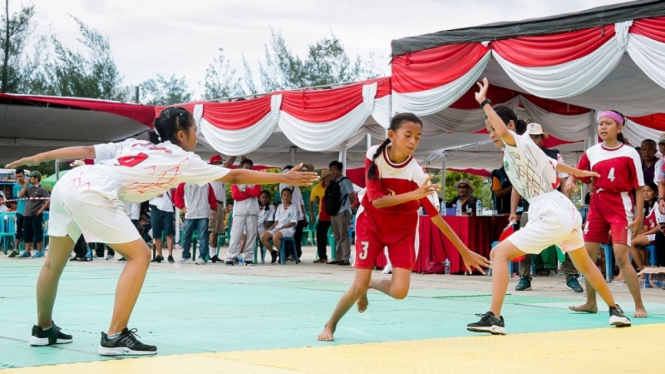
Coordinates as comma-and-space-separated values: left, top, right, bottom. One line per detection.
577, 143, 644, 193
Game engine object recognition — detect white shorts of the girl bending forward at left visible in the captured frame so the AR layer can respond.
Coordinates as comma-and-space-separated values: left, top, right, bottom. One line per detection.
48, 166, 141, 244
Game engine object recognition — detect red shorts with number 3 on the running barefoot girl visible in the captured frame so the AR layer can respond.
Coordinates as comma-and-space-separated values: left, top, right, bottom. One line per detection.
354, 207, 418, 270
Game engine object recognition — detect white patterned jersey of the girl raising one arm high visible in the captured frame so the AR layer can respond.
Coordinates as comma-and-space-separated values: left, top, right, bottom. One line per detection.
503, 131, 559, 200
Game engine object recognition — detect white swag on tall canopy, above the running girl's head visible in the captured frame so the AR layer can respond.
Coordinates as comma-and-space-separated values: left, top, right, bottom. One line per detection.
392, 51, 491, 116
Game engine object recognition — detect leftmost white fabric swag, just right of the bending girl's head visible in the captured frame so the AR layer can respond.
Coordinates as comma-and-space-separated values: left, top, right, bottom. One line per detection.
199, 95, 282, 155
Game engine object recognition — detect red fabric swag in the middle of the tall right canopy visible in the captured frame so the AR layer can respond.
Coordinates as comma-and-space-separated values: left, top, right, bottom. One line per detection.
492, 25, 615, 67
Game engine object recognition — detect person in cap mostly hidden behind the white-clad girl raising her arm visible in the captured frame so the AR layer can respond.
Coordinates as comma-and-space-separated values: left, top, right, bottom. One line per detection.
511, 123, 584, 292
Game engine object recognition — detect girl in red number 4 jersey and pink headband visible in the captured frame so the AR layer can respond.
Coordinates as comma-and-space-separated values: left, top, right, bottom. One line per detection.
566, 110, 647, 318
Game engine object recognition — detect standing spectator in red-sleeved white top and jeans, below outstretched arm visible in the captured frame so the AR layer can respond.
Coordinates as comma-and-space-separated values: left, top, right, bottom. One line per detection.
173, 182, 217, 265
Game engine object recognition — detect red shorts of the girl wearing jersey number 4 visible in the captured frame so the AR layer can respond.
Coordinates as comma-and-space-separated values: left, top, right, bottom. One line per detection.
584, 191, 634, 246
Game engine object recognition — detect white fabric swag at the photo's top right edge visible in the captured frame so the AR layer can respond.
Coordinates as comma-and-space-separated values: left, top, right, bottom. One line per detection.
626, 34, 665, 88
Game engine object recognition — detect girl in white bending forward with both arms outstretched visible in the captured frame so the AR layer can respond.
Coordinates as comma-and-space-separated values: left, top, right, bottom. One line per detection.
8, 107, 318, 355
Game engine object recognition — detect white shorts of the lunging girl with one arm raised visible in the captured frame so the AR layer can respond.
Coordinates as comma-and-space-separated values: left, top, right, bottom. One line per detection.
508, 191, 584, 254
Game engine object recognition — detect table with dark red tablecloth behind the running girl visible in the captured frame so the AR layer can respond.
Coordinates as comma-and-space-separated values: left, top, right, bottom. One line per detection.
376, 216, 508, 274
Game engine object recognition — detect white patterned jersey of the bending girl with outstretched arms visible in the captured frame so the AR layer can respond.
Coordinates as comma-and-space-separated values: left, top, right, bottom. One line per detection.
94, 139, 229, 203
